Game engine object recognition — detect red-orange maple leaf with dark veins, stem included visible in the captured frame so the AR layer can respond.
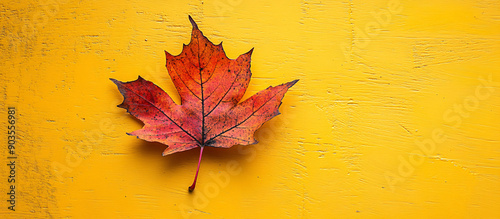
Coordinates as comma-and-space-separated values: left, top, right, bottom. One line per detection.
110, 16, 298, 191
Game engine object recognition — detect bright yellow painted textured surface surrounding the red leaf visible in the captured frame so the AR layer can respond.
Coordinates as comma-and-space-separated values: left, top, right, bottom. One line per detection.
0, 0, 500, 218
